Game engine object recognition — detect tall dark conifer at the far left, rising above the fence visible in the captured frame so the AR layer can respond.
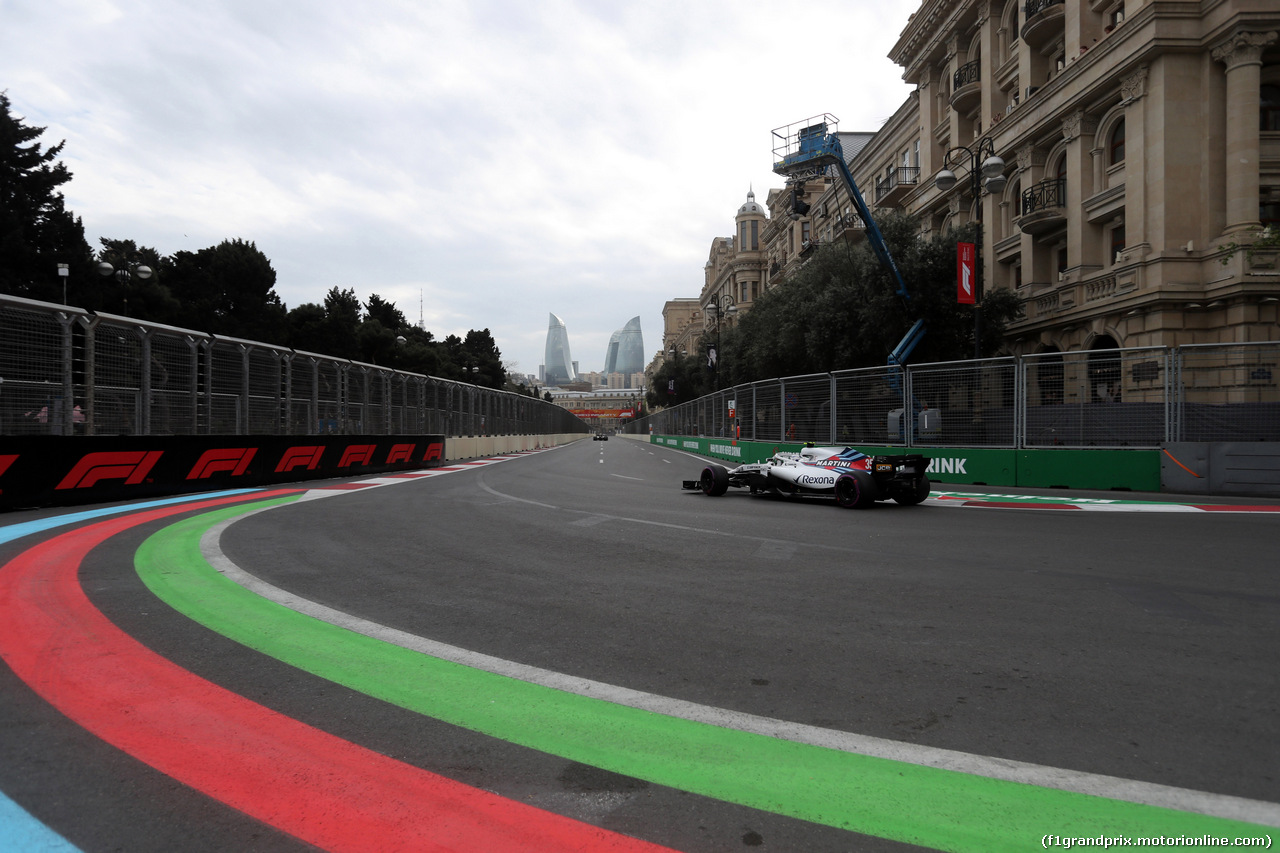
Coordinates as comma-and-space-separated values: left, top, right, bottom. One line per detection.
0, 91, 95, 302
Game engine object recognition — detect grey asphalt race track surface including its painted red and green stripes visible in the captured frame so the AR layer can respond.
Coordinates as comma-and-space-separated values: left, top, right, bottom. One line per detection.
0, 438, 1280, 853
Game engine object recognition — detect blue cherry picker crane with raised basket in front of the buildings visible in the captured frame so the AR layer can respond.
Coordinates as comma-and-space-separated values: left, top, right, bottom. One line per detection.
773, 113, 927, 366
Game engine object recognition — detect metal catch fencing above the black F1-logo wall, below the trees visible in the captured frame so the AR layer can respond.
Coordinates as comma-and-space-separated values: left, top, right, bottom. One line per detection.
0, 295, 590, 435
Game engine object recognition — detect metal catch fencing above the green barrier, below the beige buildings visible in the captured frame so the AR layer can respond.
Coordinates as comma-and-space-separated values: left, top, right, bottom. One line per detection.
627, 341, 1280, 448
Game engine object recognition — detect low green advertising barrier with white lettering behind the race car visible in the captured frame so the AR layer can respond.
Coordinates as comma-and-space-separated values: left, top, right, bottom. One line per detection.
649, 435, 1160, 492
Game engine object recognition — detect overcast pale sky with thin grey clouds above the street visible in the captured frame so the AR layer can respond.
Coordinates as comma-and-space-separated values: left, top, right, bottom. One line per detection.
0, 0, 919, 374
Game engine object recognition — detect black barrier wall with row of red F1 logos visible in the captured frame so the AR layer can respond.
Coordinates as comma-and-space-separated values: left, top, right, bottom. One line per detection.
0, 435, 444, 510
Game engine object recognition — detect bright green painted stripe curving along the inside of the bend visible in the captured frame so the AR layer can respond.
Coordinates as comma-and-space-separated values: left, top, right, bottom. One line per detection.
136, 498, 1274, 853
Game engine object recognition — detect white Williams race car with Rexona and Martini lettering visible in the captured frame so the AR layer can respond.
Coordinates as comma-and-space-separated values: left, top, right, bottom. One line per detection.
682, 447, 929, 510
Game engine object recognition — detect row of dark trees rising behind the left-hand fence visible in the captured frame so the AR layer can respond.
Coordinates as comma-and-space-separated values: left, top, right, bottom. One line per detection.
0, 91, 507, 388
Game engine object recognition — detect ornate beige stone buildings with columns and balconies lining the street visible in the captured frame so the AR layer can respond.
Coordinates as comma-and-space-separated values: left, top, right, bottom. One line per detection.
700, 0, 1280, 353
